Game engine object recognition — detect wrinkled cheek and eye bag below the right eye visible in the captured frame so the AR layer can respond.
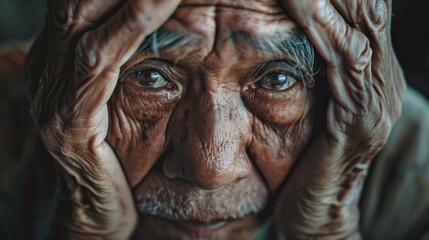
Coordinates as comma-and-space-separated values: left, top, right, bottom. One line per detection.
249, 85, 313, 192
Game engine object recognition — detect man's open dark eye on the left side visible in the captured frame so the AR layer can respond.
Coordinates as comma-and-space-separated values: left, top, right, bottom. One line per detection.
128, 69, 175, 89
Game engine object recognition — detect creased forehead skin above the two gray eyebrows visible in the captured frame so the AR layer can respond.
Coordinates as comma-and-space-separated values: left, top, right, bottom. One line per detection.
167, 0, 295, 38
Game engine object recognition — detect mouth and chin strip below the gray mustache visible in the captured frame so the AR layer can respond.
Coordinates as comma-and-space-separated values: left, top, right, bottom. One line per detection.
137, 213, 269, 240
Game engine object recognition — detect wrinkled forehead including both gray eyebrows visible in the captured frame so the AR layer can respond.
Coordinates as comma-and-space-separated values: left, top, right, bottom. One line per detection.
129, 0, 311, 71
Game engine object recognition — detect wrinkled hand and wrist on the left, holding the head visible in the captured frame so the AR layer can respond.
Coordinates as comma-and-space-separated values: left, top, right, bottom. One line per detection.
25, 0, 180, 239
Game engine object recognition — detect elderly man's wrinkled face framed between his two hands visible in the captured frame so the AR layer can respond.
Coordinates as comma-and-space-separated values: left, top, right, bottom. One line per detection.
108, 0, 313, 238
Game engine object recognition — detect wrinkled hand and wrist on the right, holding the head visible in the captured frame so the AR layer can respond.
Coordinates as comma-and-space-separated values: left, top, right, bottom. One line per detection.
276, 0, 405, 239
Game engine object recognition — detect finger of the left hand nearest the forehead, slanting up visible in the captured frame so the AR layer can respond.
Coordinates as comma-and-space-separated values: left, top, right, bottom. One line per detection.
76, 0, 180, 74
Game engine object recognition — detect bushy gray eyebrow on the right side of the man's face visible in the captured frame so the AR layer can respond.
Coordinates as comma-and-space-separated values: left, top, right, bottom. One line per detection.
231, 29, 319, 87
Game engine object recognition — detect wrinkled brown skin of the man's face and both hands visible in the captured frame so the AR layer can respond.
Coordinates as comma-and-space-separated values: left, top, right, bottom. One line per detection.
26, 0, 405, 239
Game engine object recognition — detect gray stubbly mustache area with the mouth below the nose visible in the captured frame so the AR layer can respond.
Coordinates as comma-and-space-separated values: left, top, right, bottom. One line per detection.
134, 168, 269, 240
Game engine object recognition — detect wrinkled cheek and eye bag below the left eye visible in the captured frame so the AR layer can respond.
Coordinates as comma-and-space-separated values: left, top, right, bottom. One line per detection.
107, 83, 179, 187
